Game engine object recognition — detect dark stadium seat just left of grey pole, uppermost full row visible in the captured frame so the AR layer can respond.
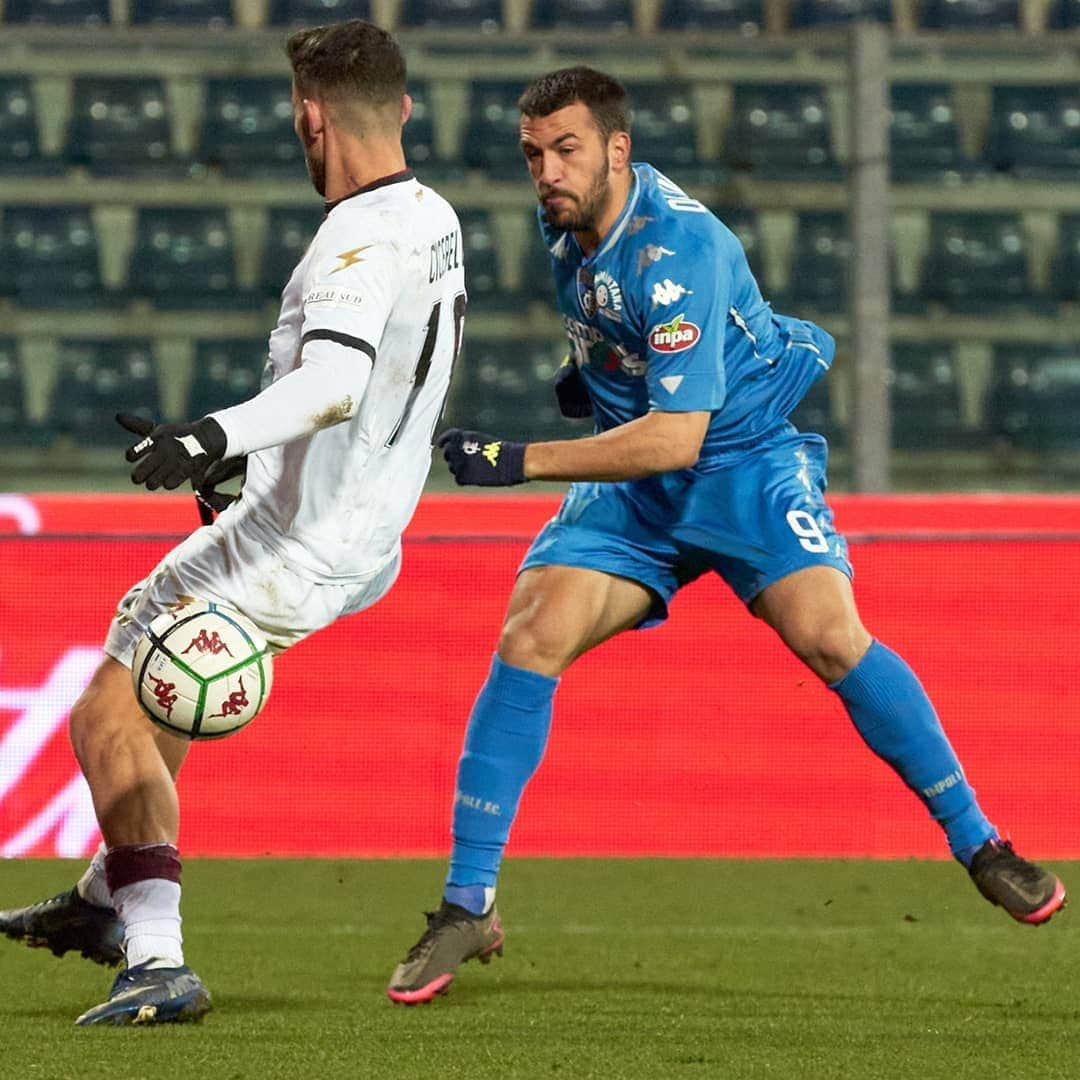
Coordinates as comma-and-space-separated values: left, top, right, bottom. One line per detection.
724, 83, 840, 180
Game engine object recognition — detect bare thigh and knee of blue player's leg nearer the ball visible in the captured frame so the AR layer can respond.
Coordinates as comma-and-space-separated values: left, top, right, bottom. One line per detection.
498, 565, 654, 676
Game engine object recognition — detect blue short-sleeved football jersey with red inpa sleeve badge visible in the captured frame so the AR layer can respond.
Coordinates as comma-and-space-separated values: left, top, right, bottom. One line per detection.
538, 164, 835, 463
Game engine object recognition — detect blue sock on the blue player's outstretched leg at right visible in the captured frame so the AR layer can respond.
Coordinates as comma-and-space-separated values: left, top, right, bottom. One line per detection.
829, 642, 998, 866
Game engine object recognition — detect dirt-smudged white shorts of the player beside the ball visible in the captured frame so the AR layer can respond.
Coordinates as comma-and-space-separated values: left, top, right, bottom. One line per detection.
105, 524, 401, 667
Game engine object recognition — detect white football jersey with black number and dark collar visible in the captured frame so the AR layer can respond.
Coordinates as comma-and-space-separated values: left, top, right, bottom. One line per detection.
219, 172, 465, 581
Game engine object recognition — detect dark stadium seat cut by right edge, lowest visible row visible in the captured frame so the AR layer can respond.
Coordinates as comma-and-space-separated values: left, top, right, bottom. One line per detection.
985, 342, 1080, 450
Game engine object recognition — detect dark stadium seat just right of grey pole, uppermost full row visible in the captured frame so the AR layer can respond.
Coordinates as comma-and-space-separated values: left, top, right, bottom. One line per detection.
889, 83, 975, 183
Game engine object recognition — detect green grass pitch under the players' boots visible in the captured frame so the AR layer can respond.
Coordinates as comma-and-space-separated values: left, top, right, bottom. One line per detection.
0, 860, 1080, 1080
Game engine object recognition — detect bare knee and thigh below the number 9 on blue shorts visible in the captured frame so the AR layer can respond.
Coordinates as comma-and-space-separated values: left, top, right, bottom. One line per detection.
751, 566, 870, 683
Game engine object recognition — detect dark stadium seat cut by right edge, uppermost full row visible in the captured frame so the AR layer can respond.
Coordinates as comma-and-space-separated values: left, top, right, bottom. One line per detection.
986, 83, 1080, 179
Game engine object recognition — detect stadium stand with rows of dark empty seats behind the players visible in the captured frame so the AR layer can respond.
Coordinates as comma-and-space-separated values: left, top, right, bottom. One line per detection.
0, 0, 1080, 489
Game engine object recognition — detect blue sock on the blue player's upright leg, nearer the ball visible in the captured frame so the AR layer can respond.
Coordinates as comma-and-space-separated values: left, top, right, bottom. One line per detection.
445, 657, 558, 915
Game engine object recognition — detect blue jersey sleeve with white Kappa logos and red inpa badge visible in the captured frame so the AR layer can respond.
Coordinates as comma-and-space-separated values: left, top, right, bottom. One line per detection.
635, 227, 733, 413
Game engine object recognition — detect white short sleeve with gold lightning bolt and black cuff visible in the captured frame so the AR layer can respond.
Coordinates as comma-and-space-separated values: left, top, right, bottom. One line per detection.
300, 239, 405, 363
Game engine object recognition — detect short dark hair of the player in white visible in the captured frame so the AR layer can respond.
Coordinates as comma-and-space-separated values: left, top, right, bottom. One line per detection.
285, 18, 405, 106
